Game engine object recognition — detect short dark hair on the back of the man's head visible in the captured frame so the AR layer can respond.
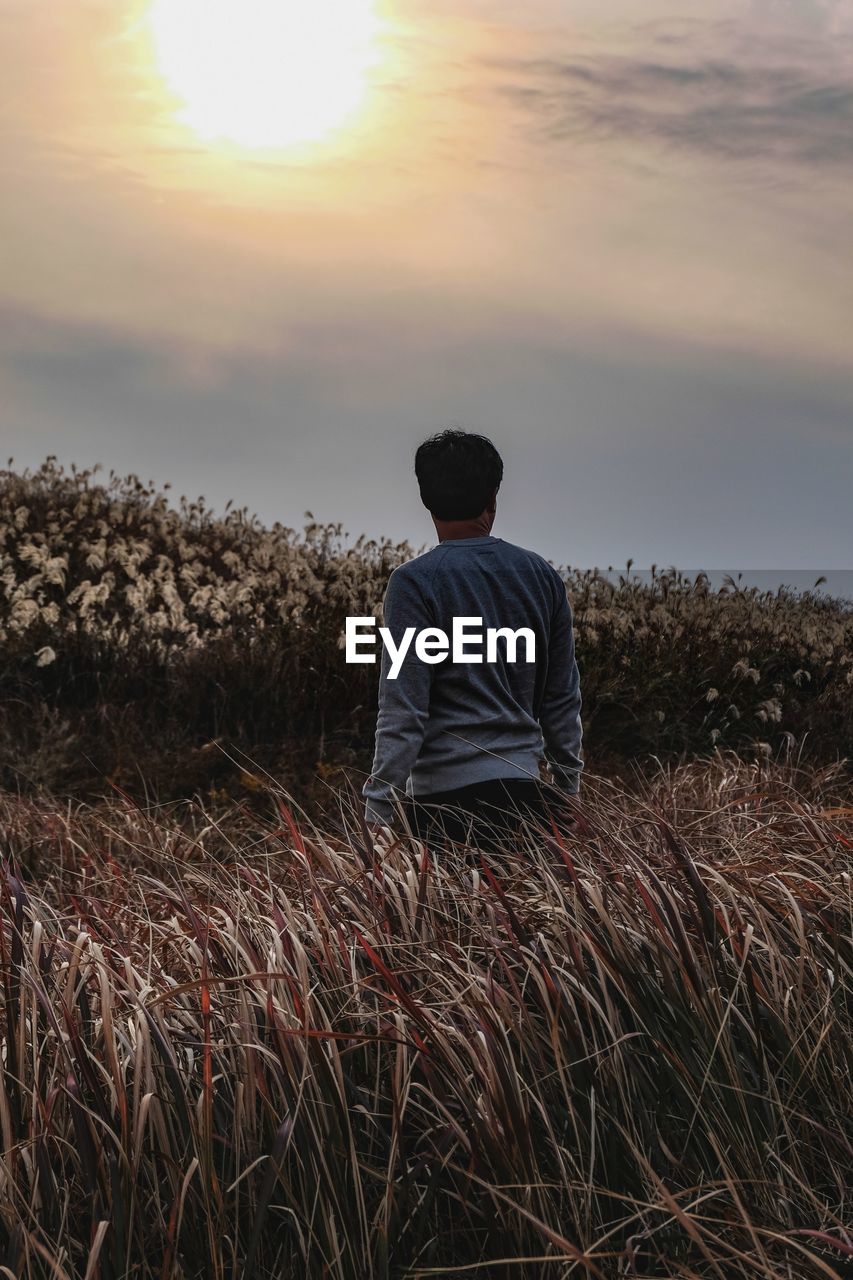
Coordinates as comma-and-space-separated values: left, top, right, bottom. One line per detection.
415, 429, 503, 520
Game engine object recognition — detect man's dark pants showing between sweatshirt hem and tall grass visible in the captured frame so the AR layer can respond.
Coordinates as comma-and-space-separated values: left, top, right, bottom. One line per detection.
407, 778, 549, 850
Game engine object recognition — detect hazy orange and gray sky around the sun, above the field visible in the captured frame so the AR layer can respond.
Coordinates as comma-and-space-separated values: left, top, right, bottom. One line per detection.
0, 0, 853, 568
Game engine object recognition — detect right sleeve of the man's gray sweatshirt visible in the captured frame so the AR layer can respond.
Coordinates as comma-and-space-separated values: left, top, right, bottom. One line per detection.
539, 581, 584, 795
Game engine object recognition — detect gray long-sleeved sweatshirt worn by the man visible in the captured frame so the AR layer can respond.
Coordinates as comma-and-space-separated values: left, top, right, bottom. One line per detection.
364, 536, 583, 826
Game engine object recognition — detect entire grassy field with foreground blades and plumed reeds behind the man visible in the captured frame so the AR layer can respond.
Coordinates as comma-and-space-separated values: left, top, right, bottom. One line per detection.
0, 461, 853, 1280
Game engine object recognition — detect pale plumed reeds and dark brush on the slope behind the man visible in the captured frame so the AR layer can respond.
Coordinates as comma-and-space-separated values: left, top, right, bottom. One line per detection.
0, 458, 853, 797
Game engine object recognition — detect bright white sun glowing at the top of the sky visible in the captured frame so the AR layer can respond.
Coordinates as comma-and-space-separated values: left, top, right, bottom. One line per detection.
150, 0, 379, 147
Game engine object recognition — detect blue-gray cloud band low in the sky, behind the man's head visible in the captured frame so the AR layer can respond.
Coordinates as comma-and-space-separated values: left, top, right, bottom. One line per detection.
0, 296, 853, 567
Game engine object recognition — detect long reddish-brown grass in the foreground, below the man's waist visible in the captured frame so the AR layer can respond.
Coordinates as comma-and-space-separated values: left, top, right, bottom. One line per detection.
0, 753, 853, 1280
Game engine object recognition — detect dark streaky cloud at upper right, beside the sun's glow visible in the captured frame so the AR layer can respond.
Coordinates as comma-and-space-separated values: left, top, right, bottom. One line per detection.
481, 37, 853, 168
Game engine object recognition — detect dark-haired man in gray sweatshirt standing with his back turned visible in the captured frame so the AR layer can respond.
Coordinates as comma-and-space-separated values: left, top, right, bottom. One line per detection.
364, 430, 583, 842
